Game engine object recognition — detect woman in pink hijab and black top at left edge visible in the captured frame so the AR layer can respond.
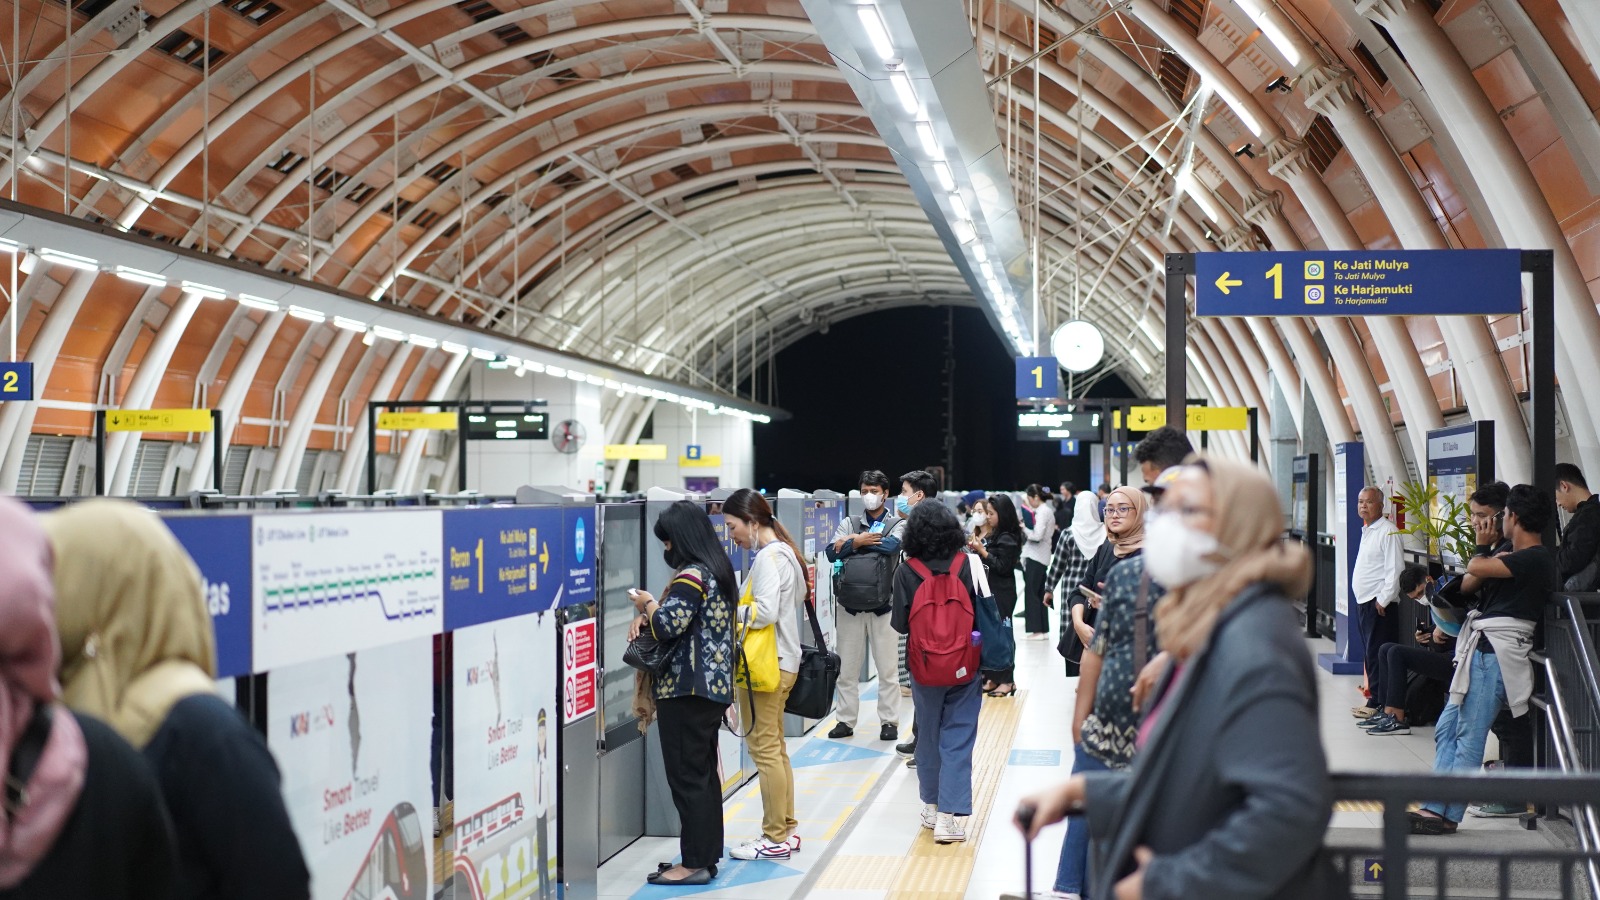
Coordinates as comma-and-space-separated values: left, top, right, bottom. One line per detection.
0, 498, 178, 900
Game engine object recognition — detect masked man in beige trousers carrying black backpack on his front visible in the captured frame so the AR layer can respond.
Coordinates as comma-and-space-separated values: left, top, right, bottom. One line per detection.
827, 469, 906, 740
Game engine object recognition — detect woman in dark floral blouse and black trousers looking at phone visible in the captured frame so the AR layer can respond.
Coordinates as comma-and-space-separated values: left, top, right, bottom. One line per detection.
629, 500, 739, 886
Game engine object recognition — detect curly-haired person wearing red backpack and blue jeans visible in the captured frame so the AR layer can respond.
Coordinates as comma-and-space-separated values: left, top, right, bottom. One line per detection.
890, 503, 982, 844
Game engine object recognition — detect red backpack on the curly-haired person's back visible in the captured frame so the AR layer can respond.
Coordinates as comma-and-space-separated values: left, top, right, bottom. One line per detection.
906, 552, 981, 687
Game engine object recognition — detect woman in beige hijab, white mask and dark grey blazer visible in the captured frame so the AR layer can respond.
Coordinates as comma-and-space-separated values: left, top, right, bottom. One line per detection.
1018, 458, 1347, 900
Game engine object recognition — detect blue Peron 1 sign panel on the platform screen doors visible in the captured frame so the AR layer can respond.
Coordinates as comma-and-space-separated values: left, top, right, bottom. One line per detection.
443, 506, 565, 631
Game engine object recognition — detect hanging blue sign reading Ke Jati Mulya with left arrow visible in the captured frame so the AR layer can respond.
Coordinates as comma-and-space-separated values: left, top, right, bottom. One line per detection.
1195, 250, 1522, 315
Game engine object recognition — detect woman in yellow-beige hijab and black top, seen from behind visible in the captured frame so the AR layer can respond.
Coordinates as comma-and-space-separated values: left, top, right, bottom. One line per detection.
42, 500, 310, 900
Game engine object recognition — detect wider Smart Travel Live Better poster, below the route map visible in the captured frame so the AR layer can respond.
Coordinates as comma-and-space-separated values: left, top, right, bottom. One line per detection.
270, 639, 432, 900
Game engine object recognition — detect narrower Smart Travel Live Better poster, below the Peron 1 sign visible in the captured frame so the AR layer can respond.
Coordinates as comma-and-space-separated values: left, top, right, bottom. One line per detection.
453, 612, 560, 900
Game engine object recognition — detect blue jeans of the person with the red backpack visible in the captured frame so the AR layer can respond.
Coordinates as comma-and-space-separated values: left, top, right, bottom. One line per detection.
910, 677, 984, 815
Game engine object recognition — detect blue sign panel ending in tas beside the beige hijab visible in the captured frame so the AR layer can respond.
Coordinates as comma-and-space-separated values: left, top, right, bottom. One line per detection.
163, 516, 254, 677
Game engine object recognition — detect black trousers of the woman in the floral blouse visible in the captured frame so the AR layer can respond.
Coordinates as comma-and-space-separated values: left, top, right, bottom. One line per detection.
656, 697, 728, 868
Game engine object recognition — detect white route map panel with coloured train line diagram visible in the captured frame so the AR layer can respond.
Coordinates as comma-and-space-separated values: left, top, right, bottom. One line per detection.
251, 509, 445, 669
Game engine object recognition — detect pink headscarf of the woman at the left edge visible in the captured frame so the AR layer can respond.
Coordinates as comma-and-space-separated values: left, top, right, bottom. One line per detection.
0, 496, 88, 889
